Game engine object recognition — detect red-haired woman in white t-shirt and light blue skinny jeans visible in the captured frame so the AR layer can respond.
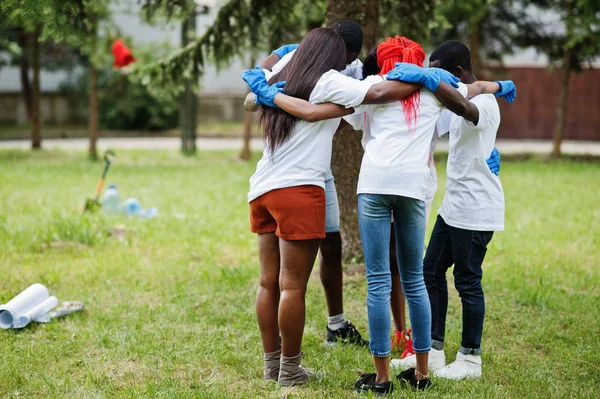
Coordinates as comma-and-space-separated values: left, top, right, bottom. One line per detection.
248, 38, 516, 393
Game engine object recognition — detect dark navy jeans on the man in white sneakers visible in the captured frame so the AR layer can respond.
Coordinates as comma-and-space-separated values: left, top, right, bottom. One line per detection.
423, 215, 493, 355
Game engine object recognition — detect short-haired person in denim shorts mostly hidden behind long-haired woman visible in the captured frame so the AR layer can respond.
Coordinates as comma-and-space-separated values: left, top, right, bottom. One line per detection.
247, 20, 369, 346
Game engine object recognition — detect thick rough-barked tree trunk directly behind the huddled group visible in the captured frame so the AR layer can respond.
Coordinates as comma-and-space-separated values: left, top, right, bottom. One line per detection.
325, 0, 379, 260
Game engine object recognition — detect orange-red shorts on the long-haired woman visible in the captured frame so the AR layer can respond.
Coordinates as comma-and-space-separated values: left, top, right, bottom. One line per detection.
250, 185, 325, 240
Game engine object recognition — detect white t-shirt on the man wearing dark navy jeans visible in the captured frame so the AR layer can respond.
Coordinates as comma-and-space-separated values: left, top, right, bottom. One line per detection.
439, 94, 504, 231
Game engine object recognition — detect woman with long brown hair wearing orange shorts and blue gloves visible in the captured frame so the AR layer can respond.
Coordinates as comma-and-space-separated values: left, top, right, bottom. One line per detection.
242, 28, 442, 386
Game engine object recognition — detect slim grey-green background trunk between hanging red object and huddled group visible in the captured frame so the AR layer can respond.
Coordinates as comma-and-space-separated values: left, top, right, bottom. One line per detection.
179, 13, 197, 154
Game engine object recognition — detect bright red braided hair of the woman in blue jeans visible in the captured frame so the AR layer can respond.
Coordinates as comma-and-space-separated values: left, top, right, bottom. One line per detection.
377, 36, 425, 132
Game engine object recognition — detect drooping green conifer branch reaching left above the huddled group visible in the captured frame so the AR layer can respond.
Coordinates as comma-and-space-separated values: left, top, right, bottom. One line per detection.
133, 0, 326, 98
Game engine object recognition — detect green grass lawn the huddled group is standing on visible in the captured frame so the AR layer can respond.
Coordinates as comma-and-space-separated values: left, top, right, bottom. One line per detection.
0, 151, 600, 399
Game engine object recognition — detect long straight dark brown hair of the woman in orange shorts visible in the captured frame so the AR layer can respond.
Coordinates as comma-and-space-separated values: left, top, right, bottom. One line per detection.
260, 28, 346, 153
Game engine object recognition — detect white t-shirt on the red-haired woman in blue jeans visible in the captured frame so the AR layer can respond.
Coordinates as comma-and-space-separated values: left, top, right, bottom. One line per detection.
345, 76, 467, 201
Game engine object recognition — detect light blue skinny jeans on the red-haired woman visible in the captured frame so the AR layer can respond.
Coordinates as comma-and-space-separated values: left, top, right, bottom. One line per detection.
358, 194, 431, 357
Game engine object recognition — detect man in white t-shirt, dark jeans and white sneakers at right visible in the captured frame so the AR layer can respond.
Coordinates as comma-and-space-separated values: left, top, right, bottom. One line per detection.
399, 40, 516, 379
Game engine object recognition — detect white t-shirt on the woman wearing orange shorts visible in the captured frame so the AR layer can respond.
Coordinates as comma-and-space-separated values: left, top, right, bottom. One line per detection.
248, 70, 372, 202
